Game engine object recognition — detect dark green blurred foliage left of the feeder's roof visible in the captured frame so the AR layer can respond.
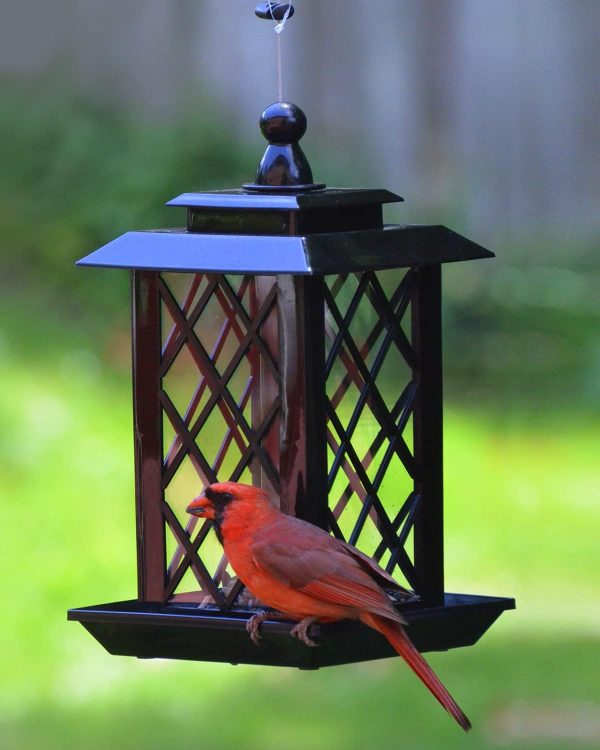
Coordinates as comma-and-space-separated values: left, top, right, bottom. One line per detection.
0, 86, 254, 318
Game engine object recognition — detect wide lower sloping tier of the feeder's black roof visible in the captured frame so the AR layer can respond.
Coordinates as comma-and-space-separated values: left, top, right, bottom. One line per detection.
77, 225, 494, 275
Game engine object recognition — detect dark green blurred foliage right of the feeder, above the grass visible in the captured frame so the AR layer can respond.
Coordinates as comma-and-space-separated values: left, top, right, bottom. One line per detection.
444, 252, 600, 416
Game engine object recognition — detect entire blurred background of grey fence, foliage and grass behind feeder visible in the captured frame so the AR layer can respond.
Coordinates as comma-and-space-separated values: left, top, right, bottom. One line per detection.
0, 0, 600, 750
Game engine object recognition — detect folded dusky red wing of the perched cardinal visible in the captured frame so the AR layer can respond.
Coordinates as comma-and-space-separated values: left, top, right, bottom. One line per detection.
252, 528, 405, 623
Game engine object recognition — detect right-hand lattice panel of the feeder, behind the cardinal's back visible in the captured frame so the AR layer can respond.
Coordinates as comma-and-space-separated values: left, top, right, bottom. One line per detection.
325, 271, 420, 588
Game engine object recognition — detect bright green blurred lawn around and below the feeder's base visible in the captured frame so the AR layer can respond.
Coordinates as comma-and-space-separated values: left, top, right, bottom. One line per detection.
0, 296, 600, 750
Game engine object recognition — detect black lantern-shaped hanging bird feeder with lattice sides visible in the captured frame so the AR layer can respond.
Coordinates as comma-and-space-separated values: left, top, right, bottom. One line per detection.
68, 8, 514, 669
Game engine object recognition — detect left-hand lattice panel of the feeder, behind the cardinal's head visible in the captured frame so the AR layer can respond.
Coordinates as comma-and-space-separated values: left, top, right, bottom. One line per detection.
159, 274, 281, 609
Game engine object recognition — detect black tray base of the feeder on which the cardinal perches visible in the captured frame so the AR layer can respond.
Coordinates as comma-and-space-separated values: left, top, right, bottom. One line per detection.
68, 594, 515, 669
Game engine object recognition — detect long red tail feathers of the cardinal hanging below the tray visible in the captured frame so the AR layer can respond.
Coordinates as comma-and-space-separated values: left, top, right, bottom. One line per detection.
360, 612, 471, 732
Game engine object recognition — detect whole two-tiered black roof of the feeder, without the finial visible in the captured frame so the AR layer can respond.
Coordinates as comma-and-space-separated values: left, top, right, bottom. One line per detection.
77, 188, 493, 274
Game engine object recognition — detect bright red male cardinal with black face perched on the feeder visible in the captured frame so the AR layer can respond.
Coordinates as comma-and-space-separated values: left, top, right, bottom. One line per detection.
187, 482, 471, 731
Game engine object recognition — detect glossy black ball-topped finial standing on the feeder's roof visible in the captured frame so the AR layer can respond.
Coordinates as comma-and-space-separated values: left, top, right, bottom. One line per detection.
244, 102, 325, 192
